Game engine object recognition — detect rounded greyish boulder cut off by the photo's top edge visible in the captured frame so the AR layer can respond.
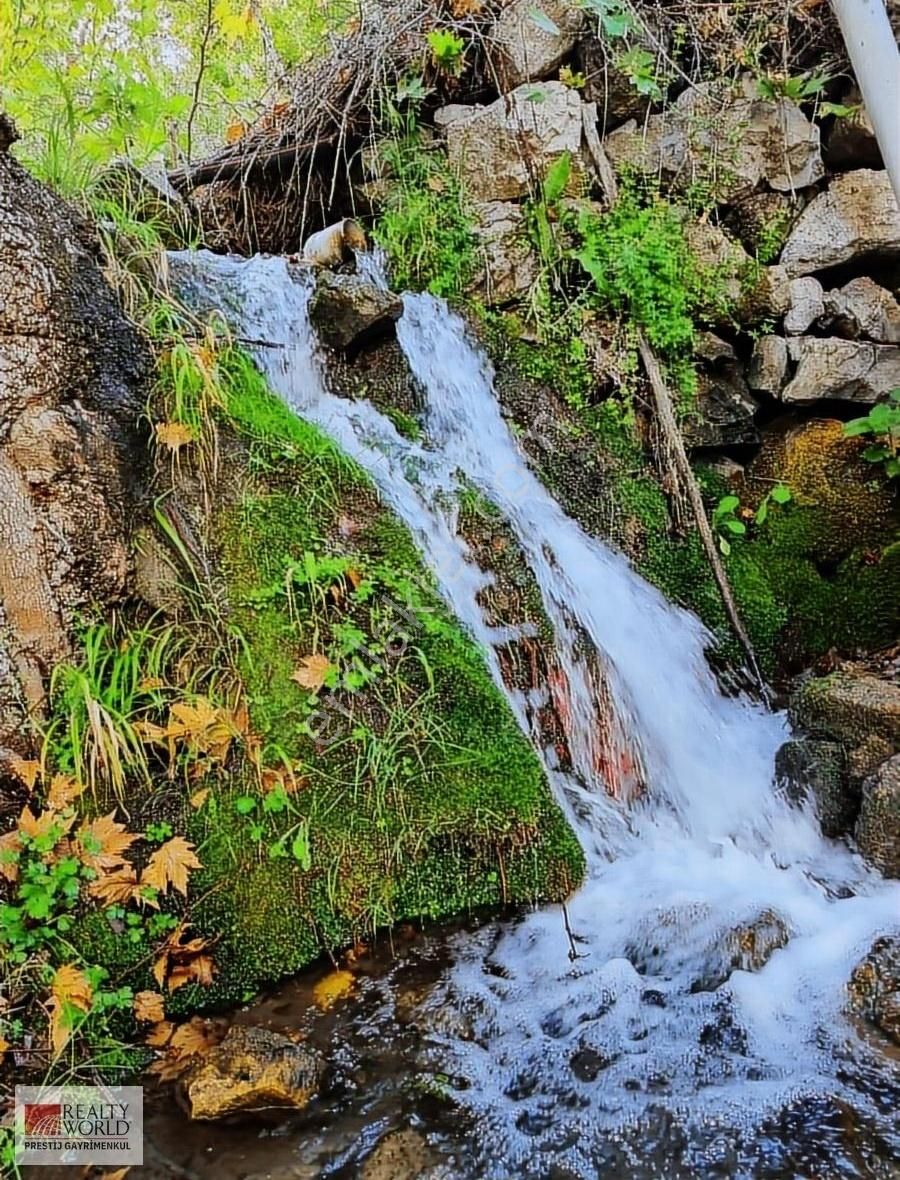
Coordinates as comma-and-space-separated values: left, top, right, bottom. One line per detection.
488, 0, 584, 91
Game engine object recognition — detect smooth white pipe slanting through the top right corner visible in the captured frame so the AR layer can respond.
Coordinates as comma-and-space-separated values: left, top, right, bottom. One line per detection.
832, 0, 900, 207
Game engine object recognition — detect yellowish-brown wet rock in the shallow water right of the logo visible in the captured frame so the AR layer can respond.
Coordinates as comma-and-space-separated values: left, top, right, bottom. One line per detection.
184, 1024, 323, 1119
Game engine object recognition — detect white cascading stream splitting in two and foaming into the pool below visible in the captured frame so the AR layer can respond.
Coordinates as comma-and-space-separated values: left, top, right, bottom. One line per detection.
172, 246, 900, 1178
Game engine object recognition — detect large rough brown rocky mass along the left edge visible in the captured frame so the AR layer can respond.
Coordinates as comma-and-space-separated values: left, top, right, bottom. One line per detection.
0, 116, 150, 749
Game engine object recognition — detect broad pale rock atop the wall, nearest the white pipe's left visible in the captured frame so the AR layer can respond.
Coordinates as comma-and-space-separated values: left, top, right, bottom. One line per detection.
605, 77, 825, 202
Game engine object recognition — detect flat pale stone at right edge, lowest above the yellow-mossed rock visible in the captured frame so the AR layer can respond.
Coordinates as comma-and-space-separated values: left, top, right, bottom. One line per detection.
781, 336, 900, 406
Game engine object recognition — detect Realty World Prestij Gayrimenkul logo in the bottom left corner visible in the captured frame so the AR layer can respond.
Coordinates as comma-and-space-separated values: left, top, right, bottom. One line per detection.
15, 1086, 144, 1166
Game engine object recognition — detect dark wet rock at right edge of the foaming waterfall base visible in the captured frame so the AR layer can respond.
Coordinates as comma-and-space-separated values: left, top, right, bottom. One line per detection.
775, 738, 860, 839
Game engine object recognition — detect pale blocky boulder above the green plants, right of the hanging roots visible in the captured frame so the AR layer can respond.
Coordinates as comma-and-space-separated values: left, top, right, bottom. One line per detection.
444, 81, 582, 202
